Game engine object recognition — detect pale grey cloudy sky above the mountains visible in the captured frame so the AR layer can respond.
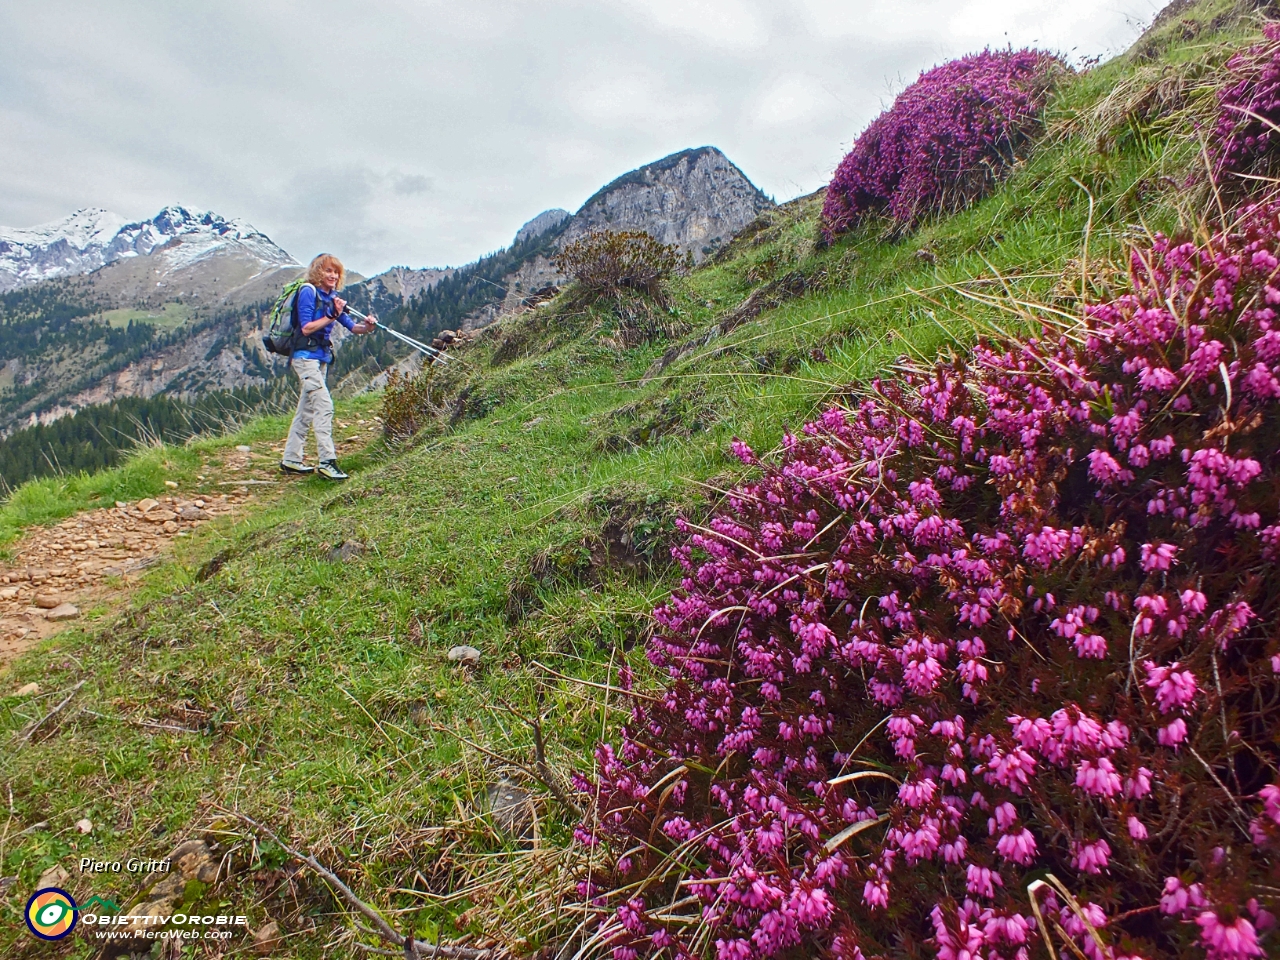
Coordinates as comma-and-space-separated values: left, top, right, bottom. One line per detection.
0, 0, 1164, 274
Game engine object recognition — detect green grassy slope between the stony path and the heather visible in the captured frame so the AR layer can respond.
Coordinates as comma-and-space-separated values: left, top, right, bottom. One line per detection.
0, 4, 1264, 957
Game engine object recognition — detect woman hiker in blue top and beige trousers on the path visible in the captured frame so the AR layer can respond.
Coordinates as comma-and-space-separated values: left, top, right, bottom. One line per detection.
280, 253, 375, 480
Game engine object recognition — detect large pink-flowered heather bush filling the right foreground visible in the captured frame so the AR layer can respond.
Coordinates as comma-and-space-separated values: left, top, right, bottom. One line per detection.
579, 202, 1280, 960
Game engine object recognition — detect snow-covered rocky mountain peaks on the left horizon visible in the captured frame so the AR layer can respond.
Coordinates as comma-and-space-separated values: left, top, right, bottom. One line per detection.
0, 206, 297, 292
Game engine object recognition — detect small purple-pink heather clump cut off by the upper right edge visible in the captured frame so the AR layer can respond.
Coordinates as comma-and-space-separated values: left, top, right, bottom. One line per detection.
1213, 23, 1280, 170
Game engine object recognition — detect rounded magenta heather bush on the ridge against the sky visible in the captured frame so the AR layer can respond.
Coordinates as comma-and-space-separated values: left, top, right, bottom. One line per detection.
822, 50, 1062, 239
